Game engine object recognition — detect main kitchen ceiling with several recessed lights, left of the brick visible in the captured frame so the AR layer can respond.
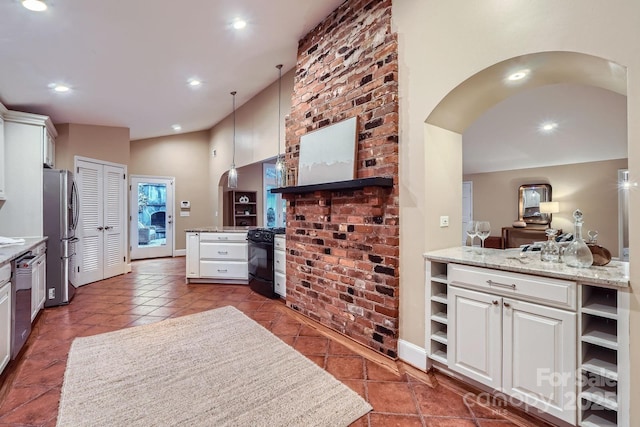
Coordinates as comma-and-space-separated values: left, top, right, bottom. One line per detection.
0, 0, 344, 140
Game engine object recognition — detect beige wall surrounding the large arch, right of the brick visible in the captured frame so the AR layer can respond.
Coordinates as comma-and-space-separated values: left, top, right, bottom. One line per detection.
393, 0, 640, 420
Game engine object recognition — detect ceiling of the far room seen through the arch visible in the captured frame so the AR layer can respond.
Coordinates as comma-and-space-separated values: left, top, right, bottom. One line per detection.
462, 83, 628, 174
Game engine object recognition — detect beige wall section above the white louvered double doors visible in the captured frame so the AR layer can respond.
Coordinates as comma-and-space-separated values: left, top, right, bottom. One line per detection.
56, 123, 129, 170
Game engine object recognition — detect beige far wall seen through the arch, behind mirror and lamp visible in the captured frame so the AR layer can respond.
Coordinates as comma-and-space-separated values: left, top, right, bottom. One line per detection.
463, 159, 627, 257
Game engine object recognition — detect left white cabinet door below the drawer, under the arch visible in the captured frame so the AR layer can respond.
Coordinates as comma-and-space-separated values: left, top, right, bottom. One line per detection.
447, 286, 502, 389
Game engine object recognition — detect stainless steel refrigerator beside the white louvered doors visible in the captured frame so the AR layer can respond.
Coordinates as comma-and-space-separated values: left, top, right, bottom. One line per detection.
43, 169, 80, 307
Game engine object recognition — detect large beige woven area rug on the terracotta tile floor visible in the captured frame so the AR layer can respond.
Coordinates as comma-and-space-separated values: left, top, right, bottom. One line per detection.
58, 307, 371, 427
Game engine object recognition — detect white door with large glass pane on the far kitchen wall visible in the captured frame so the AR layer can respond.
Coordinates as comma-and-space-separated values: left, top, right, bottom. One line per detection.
129, 175, 175, 259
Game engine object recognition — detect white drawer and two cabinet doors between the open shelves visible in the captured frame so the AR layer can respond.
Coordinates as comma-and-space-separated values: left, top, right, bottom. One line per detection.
447, 264, 577, 424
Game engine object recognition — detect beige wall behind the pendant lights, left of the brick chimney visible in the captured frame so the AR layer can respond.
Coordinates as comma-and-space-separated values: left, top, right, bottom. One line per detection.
209, 69, 294, 226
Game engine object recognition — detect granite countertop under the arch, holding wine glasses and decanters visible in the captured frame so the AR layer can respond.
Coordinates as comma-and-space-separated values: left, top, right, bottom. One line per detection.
423, 246, 629, 288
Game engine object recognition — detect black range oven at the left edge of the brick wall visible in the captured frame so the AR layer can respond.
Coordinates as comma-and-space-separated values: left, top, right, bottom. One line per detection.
247, 228, 285, 298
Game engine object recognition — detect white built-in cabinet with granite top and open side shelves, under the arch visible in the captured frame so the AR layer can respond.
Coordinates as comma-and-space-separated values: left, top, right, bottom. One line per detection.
424, 247, 630, 426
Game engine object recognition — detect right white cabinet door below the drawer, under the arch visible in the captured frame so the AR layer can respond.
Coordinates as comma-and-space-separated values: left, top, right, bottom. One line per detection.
503, 298, 577, 425
